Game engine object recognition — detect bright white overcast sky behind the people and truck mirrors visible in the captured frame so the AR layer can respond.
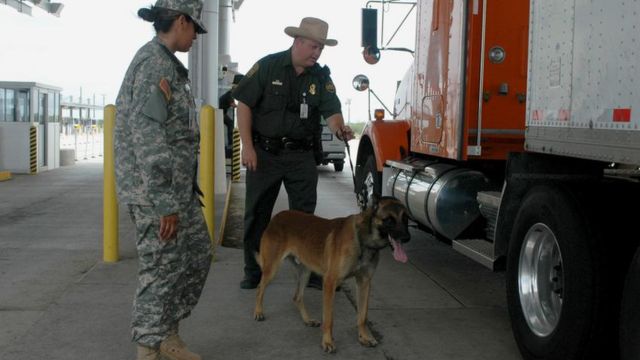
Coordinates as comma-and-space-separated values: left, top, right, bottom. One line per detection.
0, 0, 415, 121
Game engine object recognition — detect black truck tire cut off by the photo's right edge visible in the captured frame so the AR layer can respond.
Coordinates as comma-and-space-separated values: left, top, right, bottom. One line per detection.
620, 248, 640, 360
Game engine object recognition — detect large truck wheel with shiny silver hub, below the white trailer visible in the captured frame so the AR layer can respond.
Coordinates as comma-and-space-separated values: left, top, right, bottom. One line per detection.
506, 186, 604, 359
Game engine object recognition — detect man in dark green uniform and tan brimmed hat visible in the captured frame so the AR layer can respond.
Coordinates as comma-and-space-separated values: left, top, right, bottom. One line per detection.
233, 17, 353, 289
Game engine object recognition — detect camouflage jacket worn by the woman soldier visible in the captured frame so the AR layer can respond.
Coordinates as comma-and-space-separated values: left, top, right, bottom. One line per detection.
114, 37, 200, 216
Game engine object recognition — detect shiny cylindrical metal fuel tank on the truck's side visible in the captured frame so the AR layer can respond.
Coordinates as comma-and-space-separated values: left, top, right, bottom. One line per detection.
383, 161, 489, 240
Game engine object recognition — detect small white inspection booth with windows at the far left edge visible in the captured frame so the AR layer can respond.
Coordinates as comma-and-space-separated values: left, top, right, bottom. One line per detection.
0, 81, 62, 174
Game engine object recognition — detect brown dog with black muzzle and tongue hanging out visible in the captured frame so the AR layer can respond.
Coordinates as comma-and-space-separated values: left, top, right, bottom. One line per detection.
254, 197, 409, 352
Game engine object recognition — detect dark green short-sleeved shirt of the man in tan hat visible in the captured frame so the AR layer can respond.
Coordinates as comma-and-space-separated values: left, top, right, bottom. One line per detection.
233, 49, 341, 139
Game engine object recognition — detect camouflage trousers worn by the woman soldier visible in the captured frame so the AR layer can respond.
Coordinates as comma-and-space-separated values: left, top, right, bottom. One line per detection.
129, 198, 212, 348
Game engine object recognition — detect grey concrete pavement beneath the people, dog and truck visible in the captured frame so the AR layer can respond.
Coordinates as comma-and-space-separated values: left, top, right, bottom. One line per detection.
0, 161, 521, 360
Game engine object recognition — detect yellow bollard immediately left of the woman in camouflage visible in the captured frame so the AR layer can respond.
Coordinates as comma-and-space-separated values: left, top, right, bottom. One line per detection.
103, 105, 118, 262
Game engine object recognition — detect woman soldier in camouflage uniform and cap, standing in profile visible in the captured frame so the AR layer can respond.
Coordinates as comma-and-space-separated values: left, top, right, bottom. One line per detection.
114, 0, 212, 360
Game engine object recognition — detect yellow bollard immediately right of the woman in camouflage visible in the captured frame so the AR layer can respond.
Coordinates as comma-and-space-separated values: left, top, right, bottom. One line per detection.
200, 105, 216, 245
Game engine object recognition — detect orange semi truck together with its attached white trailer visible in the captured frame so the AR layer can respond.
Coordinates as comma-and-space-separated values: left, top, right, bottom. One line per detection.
354, 0, 640, 359
